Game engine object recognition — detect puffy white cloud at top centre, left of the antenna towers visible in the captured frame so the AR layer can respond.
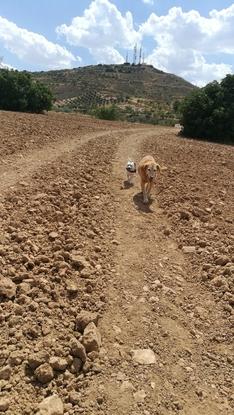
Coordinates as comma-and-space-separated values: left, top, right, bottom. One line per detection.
56, 0, 141, 63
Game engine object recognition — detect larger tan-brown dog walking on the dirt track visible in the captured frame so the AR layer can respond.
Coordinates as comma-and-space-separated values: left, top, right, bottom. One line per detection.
138, 156, 161, 203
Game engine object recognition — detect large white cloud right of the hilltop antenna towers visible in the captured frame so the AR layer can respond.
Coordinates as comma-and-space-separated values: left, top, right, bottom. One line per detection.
140, 4, 234, 85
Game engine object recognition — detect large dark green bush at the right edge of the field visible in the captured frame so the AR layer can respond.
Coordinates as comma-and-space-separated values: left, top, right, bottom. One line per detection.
180, 75, 234, 144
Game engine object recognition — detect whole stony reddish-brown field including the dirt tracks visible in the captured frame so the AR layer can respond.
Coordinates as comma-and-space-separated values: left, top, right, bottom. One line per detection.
0, 112, 234, 415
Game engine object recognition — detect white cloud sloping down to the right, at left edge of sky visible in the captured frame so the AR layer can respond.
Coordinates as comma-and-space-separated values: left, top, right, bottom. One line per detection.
0, 16, 76, 69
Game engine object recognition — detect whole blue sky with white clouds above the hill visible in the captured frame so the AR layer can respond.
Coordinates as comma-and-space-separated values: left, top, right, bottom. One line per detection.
0, 0, 234, 86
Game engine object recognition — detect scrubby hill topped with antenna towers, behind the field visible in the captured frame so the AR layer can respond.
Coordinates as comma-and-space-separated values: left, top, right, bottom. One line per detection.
33, 64, 195, 123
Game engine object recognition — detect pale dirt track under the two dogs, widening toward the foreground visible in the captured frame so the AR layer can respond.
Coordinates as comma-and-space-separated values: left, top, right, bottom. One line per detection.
83, 130, 232, 415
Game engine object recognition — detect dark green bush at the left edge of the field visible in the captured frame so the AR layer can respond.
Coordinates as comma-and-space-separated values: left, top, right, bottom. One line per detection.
0, 69, 53, 113
